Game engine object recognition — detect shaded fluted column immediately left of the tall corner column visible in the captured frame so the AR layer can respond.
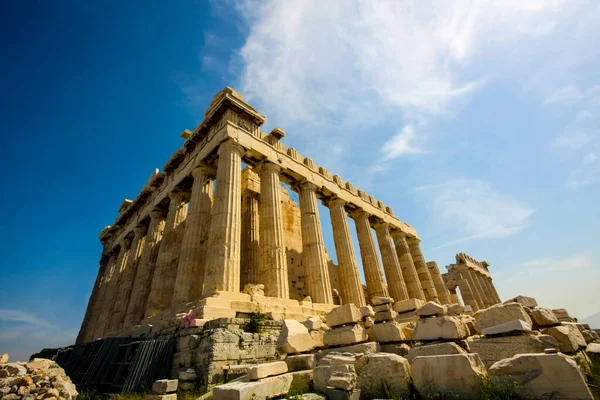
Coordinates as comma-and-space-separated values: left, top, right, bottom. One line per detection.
173, 165, 215, 305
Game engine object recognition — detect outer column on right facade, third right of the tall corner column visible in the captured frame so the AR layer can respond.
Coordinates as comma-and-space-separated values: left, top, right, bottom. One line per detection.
327, 198, 366, 307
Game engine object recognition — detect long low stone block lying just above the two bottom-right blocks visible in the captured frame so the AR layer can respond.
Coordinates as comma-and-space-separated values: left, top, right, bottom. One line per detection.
467, 335, 558, 368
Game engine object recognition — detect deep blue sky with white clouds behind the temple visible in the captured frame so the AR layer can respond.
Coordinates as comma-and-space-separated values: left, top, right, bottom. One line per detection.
0, 0, 600, 359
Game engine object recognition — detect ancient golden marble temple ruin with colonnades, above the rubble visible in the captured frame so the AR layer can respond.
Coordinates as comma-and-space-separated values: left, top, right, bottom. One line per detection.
77, 87, 499, 343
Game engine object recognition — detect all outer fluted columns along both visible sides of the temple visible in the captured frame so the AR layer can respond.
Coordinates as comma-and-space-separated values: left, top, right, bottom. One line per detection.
81, 140, 442, 341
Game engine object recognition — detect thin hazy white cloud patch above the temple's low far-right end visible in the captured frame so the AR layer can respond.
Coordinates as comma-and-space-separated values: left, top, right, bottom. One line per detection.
416, 179, 534, 249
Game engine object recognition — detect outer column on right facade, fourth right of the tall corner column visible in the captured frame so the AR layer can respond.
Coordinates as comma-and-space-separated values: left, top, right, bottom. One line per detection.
350, 210, 389, 303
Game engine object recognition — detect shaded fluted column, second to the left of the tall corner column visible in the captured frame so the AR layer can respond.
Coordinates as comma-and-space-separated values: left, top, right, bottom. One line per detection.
146, 192, 188, 317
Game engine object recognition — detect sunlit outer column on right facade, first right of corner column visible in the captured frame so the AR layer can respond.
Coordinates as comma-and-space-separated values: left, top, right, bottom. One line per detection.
257, 161, 290, 301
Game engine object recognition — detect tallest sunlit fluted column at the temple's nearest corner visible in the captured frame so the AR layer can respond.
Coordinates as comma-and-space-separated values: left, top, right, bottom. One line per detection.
202, 139, 244, 296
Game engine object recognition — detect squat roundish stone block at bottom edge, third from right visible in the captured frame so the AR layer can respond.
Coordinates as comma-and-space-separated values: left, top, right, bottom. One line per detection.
356, 353, 411, 399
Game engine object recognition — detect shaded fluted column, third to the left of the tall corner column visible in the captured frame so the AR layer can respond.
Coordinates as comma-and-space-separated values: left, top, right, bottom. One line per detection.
123, 210, 165, 328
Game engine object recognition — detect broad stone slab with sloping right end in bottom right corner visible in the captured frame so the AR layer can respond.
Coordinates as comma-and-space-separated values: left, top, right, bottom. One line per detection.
490, 354, 592, 399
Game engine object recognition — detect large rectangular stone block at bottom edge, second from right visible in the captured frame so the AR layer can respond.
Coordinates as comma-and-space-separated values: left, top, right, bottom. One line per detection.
411, 354, 487, 398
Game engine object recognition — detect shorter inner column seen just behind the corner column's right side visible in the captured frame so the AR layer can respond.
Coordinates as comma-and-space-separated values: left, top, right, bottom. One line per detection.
240, 190, 261, 290
